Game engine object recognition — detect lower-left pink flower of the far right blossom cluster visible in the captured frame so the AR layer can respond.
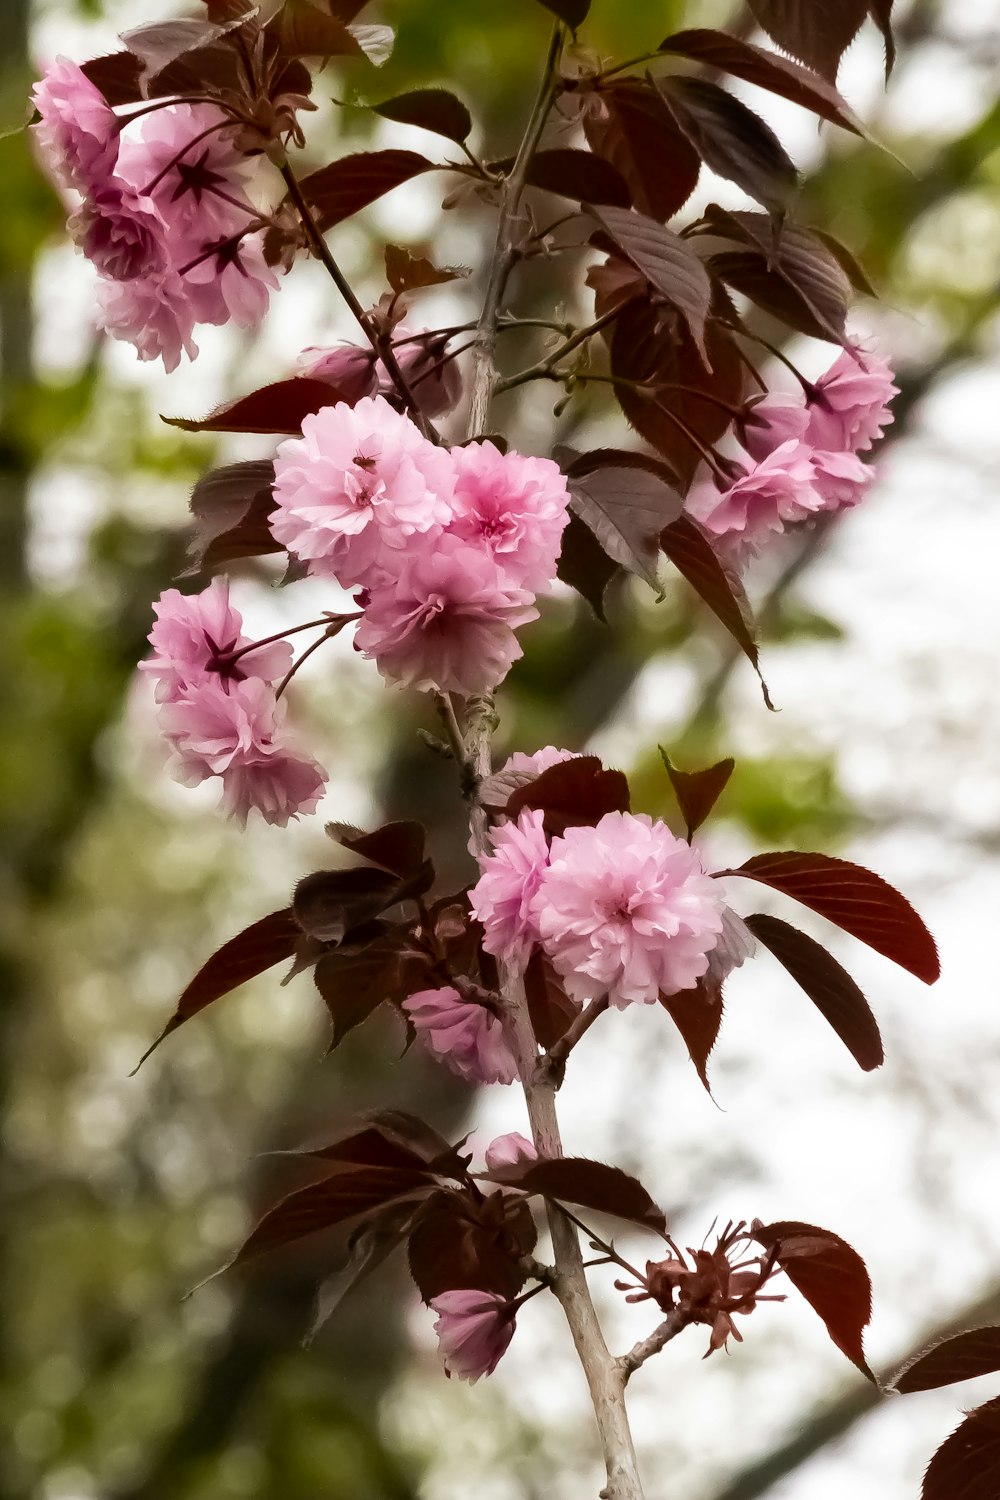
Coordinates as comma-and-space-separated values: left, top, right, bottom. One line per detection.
687, 438, 823, 542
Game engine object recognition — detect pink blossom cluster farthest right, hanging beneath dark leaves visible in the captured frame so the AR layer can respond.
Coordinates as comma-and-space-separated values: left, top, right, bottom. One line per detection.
687, 345, 897, 567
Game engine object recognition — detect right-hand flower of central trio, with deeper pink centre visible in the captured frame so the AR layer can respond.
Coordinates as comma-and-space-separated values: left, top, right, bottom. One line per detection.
448, 443, 570, 594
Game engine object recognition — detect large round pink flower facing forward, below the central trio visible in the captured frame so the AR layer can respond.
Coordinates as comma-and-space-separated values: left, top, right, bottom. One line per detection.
531, 813, 724, 1007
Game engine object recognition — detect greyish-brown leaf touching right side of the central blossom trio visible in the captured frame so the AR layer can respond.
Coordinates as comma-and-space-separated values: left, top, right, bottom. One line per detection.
567, 455, 684, 588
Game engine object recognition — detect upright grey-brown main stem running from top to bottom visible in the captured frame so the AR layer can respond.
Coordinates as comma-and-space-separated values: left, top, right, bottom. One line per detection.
463, 26, 643, 1500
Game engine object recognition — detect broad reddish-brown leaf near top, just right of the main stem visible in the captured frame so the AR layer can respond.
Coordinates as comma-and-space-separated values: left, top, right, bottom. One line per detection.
583, 78, 702, 221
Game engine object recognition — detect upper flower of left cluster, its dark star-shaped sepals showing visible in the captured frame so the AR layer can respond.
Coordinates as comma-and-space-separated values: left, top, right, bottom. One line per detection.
139, 578, 292, 704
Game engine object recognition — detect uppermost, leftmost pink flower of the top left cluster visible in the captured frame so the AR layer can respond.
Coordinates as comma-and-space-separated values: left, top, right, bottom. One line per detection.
31, 57, 118, 194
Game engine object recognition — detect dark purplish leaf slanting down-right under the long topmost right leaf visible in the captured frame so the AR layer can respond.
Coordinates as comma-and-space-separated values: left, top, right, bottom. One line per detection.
657, 75, 799, 213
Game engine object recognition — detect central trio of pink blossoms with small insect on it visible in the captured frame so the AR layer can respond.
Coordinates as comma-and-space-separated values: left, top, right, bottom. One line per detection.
271, 396, 568, 695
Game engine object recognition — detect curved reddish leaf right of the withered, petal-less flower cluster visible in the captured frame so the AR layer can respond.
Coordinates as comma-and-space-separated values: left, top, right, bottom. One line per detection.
753, 1221, 877, 1385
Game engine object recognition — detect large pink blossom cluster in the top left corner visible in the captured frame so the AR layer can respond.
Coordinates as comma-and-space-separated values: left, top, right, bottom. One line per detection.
31, 59, 277, 371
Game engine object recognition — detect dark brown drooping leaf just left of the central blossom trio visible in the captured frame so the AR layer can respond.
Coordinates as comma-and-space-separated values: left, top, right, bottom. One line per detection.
187, 459, 285, 573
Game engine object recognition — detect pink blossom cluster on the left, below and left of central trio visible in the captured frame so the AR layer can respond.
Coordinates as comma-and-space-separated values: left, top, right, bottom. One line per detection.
139, 579, 327, 827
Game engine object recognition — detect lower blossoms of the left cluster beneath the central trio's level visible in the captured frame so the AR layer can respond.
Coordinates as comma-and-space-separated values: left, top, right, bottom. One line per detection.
160, 678, 325, 827
